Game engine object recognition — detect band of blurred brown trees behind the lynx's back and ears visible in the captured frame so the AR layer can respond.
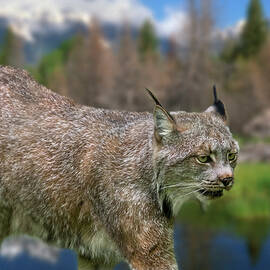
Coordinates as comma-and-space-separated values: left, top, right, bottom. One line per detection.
21, 0, 270, 132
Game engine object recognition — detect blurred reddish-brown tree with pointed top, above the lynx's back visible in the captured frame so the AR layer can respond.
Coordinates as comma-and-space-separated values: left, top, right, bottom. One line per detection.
66, 19, 115, 107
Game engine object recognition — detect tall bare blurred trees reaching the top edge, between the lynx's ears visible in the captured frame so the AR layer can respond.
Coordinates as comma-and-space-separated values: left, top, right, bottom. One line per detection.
176, 0, 214, 111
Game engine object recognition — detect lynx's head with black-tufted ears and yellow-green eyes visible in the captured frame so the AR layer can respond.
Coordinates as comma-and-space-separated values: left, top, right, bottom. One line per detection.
149, 87, 239, 216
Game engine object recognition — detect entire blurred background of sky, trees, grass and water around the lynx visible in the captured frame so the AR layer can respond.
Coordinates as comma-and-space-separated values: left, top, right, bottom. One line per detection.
0, 0, 270, 270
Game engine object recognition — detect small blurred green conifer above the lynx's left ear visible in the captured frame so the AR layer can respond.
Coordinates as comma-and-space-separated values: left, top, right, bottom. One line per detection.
139, 20, 158, 58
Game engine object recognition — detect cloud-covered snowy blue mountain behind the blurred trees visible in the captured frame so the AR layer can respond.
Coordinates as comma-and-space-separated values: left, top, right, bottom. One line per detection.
0, 0, 243, 64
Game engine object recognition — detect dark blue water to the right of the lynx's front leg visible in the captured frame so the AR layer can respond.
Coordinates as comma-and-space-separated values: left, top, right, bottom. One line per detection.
116, 223, 270, 270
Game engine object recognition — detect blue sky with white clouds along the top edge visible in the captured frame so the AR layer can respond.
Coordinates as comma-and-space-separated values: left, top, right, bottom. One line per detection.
0, 0, 270, 41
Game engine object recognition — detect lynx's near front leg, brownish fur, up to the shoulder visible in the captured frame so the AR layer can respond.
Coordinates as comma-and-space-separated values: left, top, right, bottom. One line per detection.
91, 181, 178, 270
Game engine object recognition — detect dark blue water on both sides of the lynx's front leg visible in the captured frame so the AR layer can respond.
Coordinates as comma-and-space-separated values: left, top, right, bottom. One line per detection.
0, 221, 270, 270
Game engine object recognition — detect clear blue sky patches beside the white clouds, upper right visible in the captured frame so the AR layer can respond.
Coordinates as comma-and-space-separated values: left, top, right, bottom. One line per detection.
141, 0, 270, 28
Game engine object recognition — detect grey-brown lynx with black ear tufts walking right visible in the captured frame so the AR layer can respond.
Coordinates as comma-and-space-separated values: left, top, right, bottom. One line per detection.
0, 67, 238, 270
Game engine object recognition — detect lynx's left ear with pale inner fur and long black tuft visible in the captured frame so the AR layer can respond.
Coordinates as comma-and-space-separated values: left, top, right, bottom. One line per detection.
145, 88, 176, 141
